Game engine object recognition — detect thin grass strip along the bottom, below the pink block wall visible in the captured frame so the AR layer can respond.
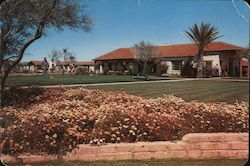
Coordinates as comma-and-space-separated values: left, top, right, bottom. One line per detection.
12, 159, 246, 166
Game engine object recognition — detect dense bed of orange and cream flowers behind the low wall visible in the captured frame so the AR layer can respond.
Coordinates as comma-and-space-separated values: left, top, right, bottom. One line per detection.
0, 88, 249, 156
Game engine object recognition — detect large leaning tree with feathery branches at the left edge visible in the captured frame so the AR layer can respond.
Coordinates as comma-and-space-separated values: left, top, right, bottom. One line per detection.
0, 0, 93, 92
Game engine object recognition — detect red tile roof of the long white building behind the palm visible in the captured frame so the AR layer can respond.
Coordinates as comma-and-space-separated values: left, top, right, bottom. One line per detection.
95, 42, 243, 61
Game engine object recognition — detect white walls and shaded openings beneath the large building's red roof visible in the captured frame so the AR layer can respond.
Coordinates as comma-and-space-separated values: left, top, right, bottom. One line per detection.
97, 51, 240, 76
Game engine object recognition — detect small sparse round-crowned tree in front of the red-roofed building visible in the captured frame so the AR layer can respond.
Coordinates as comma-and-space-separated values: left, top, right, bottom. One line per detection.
133, 41, 156, 80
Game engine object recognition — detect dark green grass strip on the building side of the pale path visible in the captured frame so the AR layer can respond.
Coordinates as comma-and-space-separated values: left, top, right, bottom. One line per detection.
7, 75, 174, 85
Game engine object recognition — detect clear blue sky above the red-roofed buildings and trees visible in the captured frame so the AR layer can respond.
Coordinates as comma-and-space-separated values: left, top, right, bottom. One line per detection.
22, 0, 250, 61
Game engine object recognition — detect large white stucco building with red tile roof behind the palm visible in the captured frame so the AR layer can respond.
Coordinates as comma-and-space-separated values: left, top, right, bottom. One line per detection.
95, 42, 243, 76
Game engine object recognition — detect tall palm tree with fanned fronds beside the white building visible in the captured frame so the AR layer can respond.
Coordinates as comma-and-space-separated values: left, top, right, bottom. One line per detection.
185, 23, 221, 78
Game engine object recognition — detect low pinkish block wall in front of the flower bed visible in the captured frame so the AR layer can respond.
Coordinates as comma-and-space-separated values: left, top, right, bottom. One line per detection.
2, 133, 248, 163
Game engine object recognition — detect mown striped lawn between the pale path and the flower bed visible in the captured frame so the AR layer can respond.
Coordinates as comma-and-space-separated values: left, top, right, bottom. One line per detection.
88, 80, 249, 103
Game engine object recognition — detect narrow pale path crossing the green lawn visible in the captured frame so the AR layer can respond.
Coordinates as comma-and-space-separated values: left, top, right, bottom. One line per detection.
23, 77, 249, 88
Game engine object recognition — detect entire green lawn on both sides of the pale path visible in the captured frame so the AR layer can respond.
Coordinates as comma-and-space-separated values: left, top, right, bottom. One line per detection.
4, 75, 249, 103
